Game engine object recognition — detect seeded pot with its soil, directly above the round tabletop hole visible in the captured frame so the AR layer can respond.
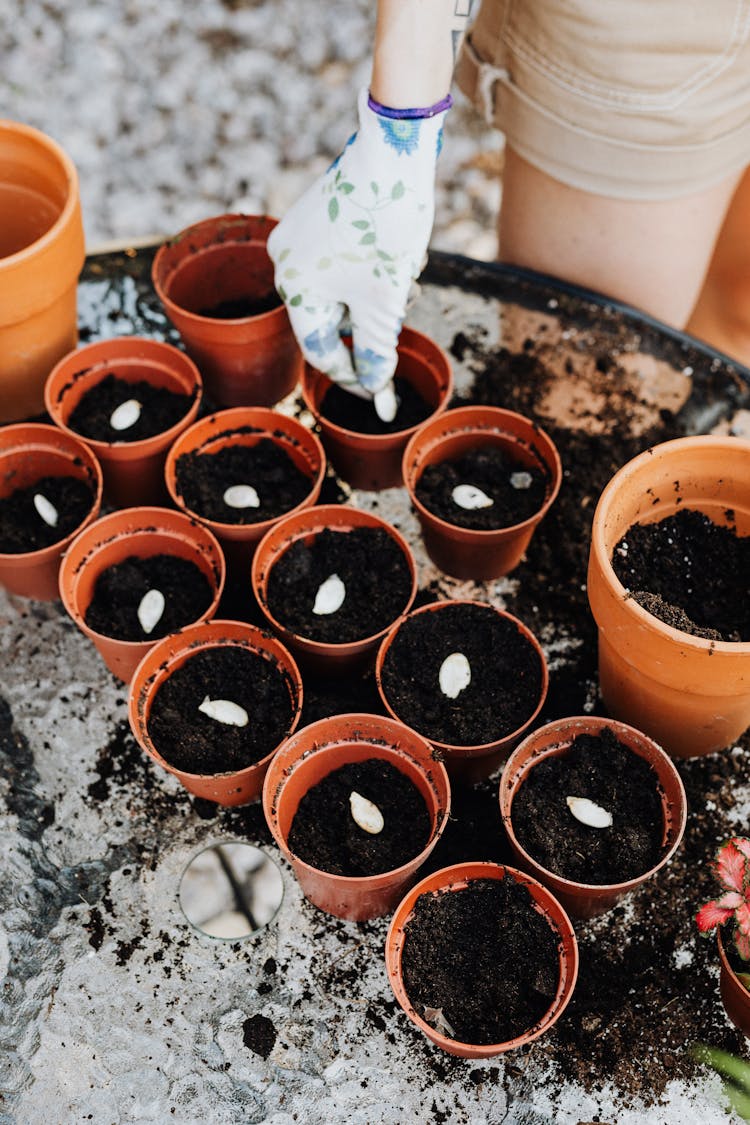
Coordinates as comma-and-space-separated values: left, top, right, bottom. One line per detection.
128, 621, 302, 806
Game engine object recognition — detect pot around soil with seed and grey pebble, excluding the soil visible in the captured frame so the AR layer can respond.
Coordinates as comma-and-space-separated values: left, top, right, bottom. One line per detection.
403, 406, 562, 582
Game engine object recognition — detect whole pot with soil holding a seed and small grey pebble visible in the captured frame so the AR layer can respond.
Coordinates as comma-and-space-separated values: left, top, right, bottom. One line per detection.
403, 406, 562, 582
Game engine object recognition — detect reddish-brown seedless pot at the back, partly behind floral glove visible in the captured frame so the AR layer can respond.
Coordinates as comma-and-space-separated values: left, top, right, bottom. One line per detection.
152, 215, 302, 406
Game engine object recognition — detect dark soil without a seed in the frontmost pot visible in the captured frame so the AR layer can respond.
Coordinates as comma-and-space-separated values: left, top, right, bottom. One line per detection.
401, 875, 560, 1044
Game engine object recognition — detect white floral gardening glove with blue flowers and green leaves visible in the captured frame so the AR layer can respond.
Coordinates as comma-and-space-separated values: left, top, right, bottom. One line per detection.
268, 83, 446, 421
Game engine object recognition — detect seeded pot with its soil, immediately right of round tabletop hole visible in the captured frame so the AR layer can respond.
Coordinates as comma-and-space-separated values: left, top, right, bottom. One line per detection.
263, 714, 450, 921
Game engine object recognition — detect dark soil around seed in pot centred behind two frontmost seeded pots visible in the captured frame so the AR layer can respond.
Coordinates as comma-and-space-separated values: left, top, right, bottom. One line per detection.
382, 605, 542, 746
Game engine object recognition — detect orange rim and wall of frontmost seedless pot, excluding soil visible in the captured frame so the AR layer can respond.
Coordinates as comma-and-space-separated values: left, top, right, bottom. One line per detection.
386, 863, 578, 1059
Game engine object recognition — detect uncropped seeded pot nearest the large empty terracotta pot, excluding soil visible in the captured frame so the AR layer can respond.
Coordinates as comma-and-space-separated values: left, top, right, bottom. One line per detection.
44, 336, 202, 507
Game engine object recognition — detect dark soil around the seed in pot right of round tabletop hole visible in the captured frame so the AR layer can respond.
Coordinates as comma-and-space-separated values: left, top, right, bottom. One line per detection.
289, 758, 431, 878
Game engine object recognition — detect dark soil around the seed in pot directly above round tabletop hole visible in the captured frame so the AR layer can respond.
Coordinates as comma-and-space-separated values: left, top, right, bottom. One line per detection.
148, 645, 295, 774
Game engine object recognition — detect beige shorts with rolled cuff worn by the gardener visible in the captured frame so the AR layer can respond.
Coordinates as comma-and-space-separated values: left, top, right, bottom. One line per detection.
457, 0, 750, 199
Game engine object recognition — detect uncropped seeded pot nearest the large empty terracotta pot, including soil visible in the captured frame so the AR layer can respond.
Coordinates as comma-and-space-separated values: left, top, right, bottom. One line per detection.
45, 336, 202, 507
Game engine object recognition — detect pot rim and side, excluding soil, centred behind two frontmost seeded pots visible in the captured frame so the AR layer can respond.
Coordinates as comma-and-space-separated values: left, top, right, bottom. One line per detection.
376, 599, 550, 783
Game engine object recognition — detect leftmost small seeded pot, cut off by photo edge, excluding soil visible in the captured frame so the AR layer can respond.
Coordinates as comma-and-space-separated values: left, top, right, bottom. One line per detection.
0, 422, 101, 602
